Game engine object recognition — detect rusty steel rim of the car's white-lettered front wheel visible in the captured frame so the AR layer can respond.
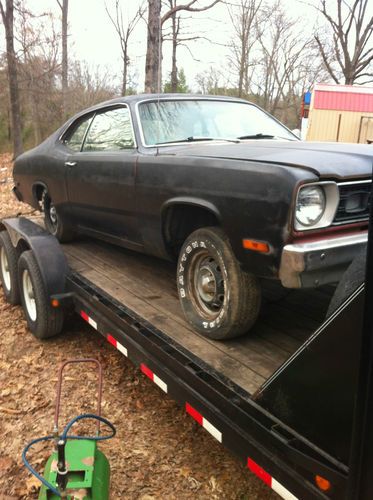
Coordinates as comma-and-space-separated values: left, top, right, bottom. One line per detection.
189, 251, 226, 320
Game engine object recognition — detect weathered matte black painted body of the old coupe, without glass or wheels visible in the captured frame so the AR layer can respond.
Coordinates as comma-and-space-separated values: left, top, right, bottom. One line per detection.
14, 95, 372, 277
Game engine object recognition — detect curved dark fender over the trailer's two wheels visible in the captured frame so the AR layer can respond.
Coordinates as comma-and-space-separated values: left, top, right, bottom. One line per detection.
0, 217, 69, 296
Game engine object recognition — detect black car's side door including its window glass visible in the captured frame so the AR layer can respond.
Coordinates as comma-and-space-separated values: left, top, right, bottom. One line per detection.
65, 105, 138, 242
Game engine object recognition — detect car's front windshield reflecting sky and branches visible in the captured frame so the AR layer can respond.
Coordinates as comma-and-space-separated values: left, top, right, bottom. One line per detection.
139, 99, 297, 146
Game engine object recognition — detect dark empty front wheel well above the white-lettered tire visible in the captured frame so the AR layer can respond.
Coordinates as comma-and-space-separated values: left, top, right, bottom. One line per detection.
162, 204, 220, 258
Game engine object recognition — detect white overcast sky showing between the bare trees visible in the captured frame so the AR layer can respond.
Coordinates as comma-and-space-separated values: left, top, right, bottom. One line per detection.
0, 0, 322, 91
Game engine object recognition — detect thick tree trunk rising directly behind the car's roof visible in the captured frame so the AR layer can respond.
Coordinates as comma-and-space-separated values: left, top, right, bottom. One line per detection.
145, 0, 161, 94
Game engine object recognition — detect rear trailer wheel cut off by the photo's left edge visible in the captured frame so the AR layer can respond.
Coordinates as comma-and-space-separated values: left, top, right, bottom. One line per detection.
0, 231, 21, 305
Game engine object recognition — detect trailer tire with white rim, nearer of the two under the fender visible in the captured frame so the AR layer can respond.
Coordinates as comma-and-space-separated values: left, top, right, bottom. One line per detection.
18, 250, 63, 339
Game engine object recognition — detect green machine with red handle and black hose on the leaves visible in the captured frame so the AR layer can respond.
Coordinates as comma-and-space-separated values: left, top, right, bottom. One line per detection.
22, 358, 116, 500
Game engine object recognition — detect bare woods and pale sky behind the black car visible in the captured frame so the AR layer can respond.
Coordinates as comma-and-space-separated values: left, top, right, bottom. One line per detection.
0, 0, 373, 156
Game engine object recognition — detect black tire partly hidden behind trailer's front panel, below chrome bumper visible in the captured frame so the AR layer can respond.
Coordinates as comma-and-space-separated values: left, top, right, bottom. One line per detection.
326, 248, 366, 318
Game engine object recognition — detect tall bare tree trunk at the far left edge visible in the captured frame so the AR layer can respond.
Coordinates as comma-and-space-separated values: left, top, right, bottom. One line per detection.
0, 0, 23, 157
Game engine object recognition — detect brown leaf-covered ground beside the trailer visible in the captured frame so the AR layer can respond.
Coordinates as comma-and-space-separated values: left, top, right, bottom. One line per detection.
0, 155, 279, 500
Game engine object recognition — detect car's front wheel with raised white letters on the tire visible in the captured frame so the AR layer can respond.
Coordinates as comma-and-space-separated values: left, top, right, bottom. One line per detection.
177, 227, 261, 340
